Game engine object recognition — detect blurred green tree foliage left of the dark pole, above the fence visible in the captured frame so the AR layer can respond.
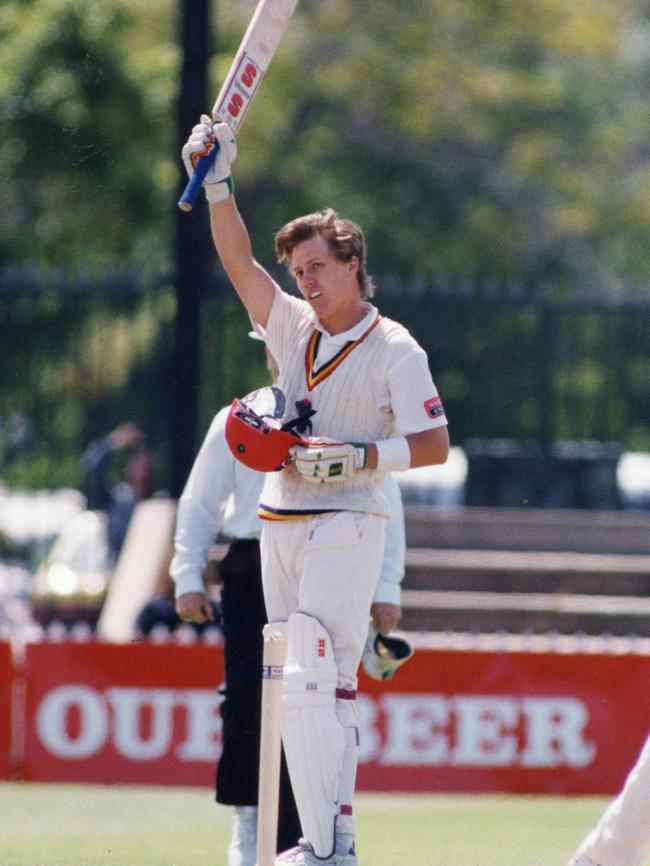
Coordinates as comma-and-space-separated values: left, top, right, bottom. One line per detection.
0, 0, 178, 267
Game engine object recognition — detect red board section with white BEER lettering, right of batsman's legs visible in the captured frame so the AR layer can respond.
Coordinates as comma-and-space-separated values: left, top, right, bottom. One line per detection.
358, 650, 650, 794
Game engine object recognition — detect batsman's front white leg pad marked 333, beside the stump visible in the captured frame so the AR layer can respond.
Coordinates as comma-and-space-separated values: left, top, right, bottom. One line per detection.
282, 613, 345, 858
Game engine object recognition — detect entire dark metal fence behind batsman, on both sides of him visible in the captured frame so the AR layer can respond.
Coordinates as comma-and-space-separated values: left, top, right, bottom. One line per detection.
0, 272, 650, 496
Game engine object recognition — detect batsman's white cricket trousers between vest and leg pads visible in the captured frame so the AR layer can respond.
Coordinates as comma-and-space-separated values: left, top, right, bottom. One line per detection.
260, 511, 386, 689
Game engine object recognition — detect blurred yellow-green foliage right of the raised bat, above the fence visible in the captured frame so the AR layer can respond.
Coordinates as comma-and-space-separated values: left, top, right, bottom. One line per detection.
237, 0, 650, 285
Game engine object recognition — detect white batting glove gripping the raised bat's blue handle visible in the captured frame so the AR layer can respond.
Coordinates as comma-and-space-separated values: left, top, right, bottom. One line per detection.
181, 114, 237, 202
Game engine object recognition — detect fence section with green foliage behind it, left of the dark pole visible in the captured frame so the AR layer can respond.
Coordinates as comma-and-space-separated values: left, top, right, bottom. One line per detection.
0, 282, 174, 489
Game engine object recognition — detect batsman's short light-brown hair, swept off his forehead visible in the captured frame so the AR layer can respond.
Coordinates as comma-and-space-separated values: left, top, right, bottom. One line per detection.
275, 208, 375, 300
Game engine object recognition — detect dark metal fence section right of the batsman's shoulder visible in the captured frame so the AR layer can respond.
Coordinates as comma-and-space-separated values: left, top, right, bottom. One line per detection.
381, 282, 650, 450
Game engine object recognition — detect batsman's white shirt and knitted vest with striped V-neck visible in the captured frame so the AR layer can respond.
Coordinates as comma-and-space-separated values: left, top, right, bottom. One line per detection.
259, 289, 447, 520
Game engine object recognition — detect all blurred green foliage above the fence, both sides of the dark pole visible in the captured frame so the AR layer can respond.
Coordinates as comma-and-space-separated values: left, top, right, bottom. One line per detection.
0, 0, 650, 287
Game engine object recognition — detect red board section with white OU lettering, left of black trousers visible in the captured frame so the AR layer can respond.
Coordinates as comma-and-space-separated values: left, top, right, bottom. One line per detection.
25, 642, 223, 785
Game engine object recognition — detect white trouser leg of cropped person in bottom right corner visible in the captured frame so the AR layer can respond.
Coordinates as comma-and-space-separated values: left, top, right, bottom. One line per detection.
575, 736, 650, 866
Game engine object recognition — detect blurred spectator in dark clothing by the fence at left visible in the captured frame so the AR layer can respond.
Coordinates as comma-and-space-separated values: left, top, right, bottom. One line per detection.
81, 423, 153, 565
